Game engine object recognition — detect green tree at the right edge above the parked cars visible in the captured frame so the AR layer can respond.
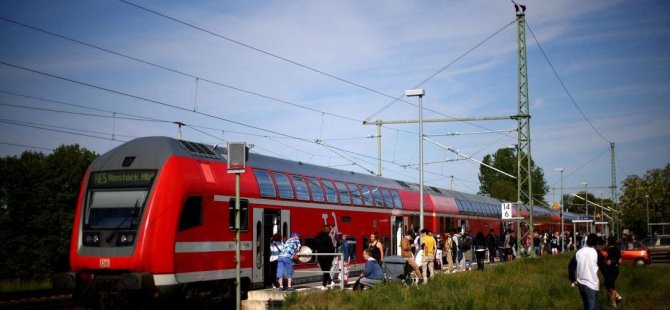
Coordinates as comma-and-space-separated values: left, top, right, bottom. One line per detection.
620, 164, 670, 236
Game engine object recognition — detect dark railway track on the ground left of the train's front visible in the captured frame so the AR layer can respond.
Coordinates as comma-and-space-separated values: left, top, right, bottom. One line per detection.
0, 290, 84, 309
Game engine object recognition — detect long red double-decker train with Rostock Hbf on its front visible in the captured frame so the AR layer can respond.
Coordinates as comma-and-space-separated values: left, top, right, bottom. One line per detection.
70, 137, 580, 306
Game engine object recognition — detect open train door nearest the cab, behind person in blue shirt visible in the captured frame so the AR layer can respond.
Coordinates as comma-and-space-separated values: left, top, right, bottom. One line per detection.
252, 208, 281, 285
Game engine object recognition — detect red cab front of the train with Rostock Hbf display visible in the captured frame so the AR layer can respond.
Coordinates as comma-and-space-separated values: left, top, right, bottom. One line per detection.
70, 138, 186, 302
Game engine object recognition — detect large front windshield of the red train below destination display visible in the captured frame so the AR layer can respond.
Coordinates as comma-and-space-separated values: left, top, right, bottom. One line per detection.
84, 189, 149, 229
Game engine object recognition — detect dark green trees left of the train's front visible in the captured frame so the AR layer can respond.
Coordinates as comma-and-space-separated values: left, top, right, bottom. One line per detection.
0, 145, 97, 279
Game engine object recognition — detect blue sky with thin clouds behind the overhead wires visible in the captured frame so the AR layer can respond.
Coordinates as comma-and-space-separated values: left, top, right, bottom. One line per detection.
0, 0, 670, 206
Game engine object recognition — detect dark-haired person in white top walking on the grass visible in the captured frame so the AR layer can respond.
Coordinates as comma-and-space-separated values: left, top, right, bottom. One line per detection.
568, 234, 604, 310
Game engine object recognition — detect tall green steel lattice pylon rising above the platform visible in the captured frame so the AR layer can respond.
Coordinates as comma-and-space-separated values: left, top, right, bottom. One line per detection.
514, 4, 535, 257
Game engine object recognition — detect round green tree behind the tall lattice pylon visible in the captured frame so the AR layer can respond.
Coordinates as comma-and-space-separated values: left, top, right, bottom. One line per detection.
479, 148, 548, 204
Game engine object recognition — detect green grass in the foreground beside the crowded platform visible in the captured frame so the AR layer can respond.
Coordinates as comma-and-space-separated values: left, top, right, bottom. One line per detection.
284, 254, 670, 310
